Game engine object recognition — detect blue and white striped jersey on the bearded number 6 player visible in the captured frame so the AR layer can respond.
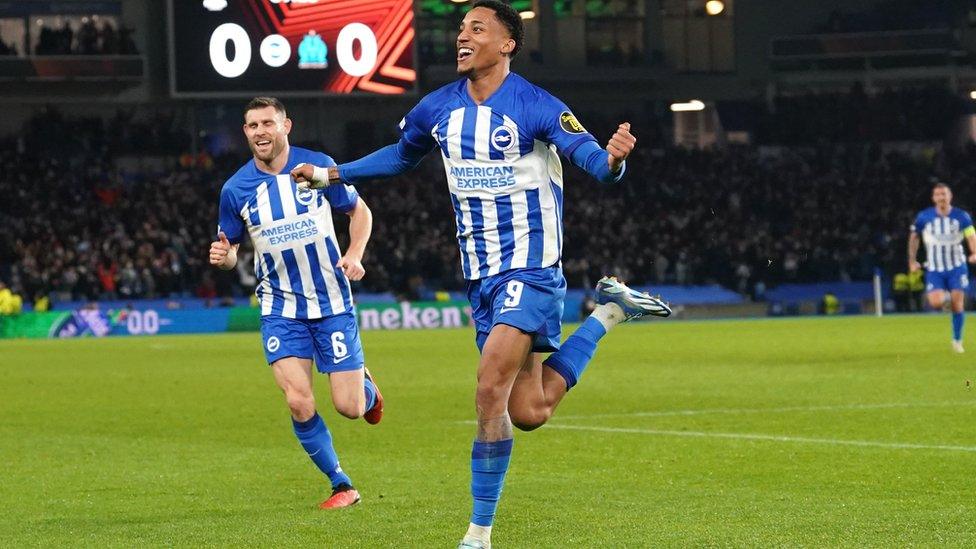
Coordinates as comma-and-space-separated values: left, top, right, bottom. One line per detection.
218, 147, 359, 319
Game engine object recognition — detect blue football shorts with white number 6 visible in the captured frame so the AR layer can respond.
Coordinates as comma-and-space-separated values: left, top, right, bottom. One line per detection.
261, 312, 365, 374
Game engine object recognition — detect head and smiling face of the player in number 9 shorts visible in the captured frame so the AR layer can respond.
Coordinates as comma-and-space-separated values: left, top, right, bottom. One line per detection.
457, 7, 515, 79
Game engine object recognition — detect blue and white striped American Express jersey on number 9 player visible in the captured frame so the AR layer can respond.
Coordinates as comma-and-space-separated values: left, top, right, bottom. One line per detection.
400, 73, 596, 280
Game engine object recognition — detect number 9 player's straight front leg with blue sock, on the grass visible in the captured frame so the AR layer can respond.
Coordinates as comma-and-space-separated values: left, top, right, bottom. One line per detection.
460, 324, 532, 547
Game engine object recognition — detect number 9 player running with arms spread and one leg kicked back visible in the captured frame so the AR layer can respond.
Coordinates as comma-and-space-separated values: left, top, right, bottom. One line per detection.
292, 0, 671, 548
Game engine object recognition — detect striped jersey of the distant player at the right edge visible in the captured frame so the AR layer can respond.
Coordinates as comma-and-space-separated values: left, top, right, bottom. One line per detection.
911, 207, 973, 273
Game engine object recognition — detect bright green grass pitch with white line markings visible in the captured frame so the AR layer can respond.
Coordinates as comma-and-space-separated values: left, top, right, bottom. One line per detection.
0, 316, 976, 548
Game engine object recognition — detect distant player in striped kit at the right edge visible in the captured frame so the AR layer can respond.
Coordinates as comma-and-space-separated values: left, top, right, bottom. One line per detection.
908, 183, 976, 353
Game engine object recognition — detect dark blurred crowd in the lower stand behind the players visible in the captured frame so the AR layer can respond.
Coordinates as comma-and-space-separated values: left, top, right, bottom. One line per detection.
0, 104, 976, 301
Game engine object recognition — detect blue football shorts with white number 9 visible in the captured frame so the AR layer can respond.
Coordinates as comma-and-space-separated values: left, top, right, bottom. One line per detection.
468, 267, 566, 353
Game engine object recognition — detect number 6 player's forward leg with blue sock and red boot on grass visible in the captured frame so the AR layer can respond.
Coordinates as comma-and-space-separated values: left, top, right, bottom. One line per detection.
271, 357, 362, 509
